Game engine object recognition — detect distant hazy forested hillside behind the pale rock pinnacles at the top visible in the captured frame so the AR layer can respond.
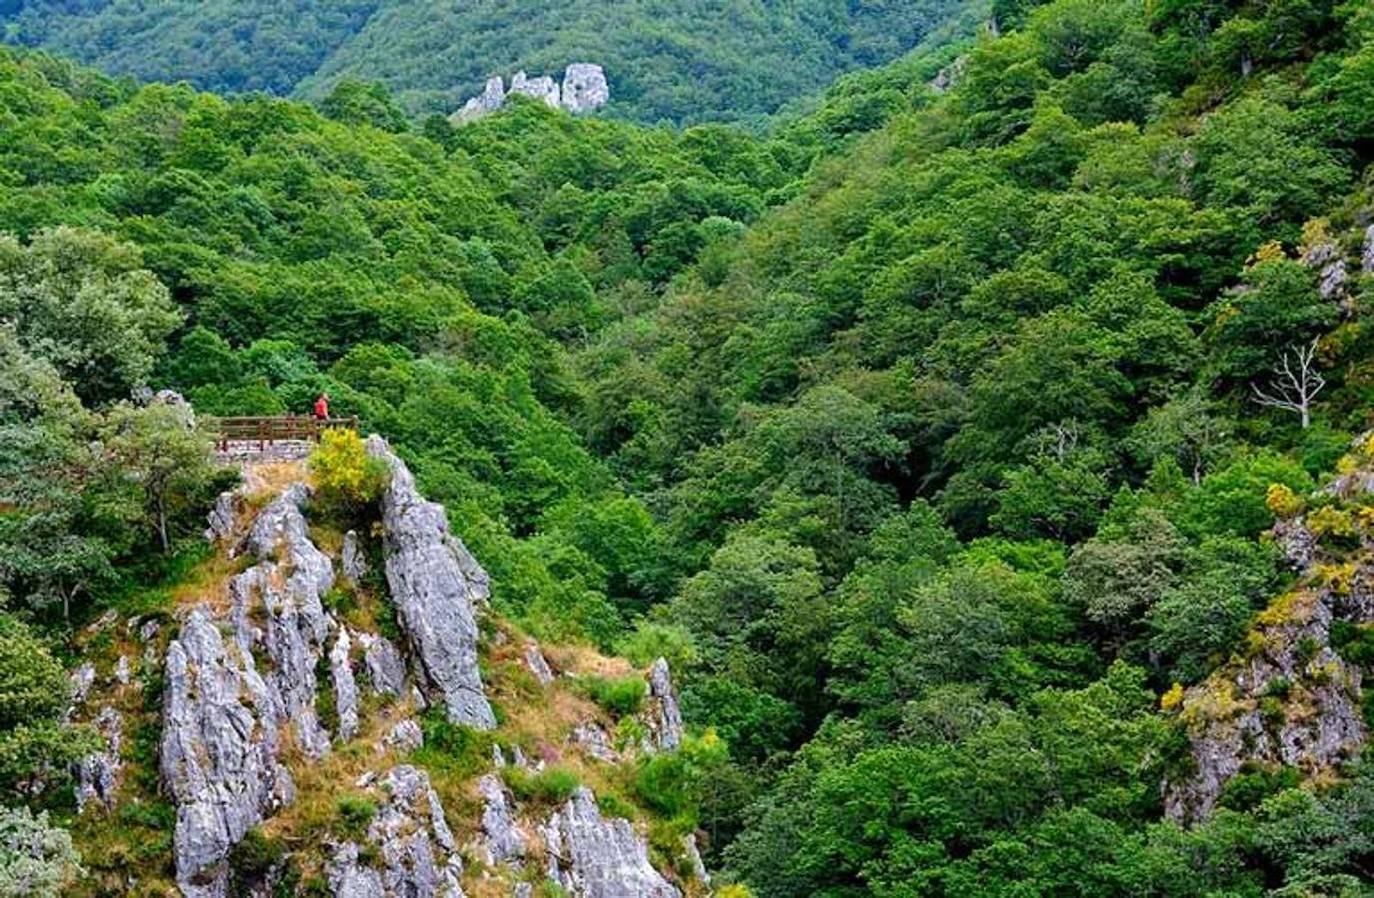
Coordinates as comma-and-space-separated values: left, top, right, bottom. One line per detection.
0, 0, 987, 124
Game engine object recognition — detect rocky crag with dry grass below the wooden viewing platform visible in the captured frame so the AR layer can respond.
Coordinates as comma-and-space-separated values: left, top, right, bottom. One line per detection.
64, 437, 708, 898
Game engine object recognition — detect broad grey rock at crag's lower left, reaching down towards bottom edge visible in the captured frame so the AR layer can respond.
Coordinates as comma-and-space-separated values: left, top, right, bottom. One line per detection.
161, 607, 294, 898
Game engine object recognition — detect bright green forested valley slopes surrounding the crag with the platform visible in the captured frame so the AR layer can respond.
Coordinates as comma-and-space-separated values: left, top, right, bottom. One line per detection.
0, 0, 1374, 898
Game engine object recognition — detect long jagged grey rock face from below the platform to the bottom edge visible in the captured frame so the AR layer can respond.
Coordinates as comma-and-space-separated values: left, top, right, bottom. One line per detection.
161, 483, 340, 898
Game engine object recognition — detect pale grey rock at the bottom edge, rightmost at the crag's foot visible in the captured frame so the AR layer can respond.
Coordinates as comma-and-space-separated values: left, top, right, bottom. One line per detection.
543, 788, 682, 898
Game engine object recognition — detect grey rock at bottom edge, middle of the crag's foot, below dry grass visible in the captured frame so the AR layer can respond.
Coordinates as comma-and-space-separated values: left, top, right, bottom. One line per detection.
327, 765, 463, 898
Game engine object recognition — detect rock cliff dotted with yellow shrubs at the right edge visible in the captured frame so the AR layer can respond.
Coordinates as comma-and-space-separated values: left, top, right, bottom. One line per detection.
1164, 437, 1374, 822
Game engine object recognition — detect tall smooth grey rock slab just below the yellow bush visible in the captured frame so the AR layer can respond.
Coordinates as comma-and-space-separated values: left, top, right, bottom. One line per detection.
367, 435, 496, 729
